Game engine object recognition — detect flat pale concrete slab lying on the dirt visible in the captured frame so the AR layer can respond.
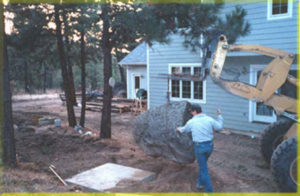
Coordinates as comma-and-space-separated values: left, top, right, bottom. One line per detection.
66, 163, 156, 192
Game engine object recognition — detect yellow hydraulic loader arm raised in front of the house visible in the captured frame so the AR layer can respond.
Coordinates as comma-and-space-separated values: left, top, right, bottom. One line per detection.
210, 35, 297, 115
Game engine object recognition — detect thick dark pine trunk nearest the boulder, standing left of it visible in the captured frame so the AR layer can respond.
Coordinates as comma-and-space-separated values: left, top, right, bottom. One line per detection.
100, 4, 112, 138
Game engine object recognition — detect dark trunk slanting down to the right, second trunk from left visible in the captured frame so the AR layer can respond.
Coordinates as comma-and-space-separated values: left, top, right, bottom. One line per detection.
54, 4, 76, 127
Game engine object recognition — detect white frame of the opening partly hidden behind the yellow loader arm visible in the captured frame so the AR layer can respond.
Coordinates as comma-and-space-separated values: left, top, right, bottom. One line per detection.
249, 65, 277, 123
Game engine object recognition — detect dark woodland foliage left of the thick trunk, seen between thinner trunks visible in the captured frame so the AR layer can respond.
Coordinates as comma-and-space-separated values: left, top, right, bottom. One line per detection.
6, 4, 110, 92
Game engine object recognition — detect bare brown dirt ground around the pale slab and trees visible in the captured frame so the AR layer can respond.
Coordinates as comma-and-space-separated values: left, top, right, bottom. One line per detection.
3, 97, 277, 192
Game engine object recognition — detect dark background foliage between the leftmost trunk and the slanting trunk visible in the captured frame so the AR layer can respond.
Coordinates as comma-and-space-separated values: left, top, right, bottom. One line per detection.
6, 4, 58, 92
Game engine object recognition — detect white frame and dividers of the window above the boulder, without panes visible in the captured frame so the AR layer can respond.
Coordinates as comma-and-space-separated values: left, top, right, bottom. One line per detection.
169, 63, 206, 104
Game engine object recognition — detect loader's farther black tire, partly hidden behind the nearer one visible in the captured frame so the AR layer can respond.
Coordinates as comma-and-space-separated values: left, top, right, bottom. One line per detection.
260, 119, 293, 164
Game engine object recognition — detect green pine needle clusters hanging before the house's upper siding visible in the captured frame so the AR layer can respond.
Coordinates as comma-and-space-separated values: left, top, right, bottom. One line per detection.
169, 1, 250, 51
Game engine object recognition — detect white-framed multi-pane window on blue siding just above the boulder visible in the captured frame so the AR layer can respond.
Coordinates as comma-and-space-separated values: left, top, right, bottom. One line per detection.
169, 64, 206, 103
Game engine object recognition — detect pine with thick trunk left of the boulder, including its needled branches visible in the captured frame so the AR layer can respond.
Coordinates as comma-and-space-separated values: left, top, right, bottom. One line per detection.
94, 1, 178, 138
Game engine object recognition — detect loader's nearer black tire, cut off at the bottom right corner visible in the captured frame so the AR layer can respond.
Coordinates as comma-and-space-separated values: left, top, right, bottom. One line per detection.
271, 137, 297, 192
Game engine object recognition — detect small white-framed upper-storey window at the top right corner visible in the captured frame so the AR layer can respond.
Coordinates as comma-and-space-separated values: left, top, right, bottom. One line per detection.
268, 0, 293, 20
